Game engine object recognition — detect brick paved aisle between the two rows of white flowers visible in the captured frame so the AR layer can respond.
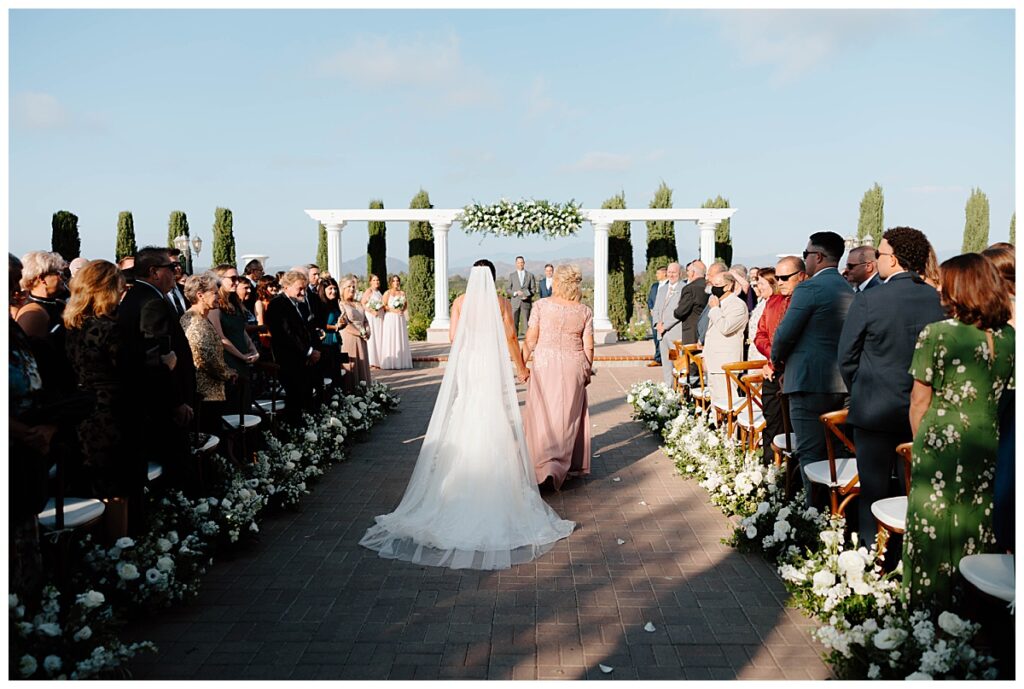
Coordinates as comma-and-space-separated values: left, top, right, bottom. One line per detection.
130, 368, 829, 680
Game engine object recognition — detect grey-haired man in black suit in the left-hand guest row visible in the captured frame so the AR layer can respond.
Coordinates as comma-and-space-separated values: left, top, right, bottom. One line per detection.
265, 270, 321, 425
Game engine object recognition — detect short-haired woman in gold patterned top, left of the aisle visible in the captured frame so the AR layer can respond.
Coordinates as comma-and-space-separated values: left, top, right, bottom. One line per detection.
181, 272, 239, 428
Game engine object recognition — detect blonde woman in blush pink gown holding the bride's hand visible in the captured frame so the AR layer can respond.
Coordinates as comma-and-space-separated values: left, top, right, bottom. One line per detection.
522, 265, 594, 490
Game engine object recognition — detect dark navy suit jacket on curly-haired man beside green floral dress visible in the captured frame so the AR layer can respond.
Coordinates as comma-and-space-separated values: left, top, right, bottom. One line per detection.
839, 272, 946, 427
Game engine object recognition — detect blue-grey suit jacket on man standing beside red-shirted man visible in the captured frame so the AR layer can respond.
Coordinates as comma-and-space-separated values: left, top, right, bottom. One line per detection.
771, 268, 853, 394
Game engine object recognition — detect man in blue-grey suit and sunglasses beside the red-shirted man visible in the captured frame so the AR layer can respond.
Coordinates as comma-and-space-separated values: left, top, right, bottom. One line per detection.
771, 232, 853, 504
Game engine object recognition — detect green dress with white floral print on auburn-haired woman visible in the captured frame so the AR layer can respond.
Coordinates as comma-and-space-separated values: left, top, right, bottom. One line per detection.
903, 318, 1015, 609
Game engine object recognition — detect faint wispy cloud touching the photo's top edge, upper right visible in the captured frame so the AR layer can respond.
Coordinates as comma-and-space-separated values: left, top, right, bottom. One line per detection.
709, 9, 908, 85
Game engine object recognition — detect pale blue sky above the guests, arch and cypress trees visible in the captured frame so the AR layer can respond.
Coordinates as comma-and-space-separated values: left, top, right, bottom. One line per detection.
9, 9, 1015, 269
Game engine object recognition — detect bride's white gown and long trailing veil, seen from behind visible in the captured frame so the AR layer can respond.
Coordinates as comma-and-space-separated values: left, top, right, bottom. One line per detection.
359, 261, 575, 569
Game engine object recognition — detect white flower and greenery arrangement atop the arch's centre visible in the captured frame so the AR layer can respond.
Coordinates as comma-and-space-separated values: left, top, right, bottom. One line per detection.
460, 199, 584, 239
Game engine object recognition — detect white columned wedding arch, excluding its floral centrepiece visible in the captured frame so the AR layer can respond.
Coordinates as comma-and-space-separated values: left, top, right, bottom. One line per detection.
305, 208, 736, 344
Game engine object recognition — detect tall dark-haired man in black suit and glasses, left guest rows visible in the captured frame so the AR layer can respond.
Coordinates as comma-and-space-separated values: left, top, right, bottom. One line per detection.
118, 247, 196, 499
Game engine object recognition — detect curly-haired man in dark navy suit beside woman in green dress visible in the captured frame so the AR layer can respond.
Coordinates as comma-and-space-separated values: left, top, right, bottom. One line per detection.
839, 227, 945, 552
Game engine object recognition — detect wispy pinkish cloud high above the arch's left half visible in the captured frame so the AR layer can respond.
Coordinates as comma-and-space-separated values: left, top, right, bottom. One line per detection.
316, 33, 498, 106
